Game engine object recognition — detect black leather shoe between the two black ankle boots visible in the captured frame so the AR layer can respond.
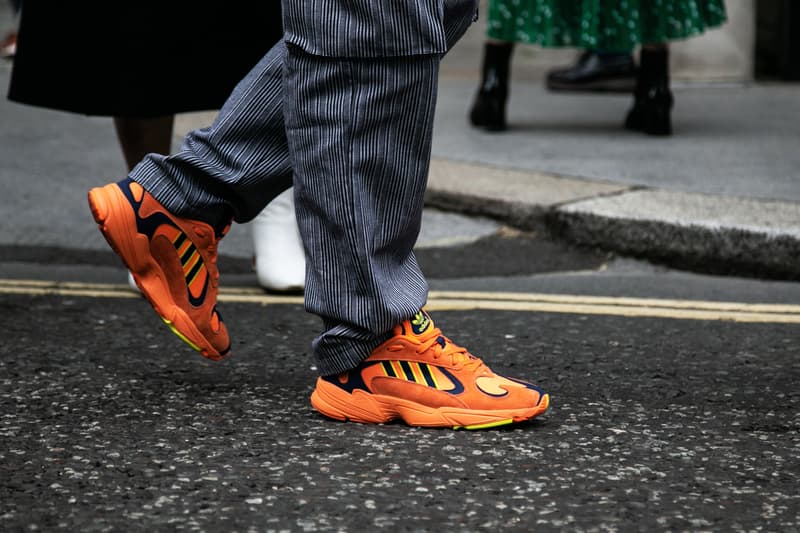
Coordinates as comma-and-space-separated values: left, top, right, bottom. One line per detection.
547, 50, 636, 93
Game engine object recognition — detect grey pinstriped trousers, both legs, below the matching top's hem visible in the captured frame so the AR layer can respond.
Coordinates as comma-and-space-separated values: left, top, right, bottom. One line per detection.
130, 0, 476, 375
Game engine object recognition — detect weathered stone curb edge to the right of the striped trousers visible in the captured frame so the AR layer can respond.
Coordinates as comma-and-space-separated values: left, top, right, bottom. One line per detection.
426, 159, 800, 280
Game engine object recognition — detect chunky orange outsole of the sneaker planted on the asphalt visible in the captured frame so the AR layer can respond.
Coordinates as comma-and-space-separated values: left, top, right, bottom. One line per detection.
311, 379, 550, 429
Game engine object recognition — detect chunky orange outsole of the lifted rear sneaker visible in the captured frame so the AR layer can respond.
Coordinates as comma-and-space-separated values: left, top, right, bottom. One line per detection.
88, 184, 230, 361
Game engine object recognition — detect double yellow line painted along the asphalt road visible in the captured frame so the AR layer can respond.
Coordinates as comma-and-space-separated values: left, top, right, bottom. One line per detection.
0, 279, 800, 324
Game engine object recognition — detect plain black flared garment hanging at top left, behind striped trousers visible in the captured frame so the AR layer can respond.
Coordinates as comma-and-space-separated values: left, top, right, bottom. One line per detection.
8, 0, 282, 117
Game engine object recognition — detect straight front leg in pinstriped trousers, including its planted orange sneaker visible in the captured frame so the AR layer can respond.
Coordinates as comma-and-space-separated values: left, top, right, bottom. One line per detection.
285, 3, 549, 429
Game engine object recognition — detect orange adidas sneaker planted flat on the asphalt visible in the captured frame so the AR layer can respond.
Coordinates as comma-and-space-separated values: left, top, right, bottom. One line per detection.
311, 311, 550, 429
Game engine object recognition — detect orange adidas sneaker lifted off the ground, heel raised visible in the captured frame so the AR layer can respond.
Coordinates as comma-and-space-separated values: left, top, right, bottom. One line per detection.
89, 179, 230, 360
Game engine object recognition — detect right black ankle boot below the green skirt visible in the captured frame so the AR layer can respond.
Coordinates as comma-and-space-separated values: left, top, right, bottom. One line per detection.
625, 48, 673, 135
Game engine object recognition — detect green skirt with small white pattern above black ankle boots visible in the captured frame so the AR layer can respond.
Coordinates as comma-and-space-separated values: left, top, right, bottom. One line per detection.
486, 0, 726, 52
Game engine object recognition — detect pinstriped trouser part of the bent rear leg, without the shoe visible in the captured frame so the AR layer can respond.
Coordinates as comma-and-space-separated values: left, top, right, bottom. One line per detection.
130, 43, 292, 226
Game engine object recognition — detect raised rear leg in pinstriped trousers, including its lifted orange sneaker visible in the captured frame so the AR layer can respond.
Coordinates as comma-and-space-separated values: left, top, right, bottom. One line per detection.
89, 43, 292, 360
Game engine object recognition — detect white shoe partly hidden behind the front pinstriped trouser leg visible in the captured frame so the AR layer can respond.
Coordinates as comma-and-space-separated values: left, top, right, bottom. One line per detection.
252, 188, 306, 292
